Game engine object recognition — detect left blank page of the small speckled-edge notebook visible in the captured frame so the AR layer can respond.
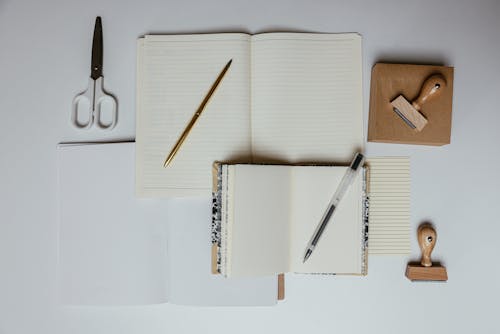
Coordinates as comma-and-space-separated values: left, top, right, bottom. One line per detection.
228, 165, 290, 277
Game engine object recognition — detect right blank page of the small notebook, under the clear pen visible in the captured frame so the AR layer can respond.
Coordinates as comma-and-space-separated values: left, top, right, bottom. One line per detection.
290, 166, 364, 274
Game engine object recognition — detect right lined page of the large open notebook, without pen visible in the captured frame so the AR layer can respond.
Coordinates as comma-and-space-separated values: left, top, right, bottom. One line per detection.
252, 33, 363, 163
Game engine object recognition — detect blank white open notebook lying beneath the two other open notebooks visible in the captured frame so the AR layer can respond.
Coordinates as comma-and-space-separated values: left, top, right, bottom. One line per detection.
58, 143, 278, 305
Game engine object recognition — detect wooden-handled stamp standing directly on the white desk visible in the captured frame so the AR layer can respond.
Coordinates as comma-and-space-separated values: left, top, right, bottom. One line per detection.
406, 224, 448, 281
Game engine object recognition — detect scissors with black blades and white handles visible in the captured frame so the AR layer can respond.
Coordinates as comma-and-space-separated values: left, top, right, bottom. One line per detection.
71, 16, 118, 130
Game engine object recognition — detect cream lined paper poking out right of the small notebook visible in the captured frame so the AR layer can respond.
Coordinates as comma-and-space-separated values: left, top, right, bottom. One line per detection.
367, 157, 410, 255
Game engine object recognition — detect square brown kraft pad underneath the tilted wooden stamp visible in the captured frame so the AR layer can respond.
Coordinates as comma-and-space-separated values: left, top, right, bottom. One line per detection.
368, 63, 454, 146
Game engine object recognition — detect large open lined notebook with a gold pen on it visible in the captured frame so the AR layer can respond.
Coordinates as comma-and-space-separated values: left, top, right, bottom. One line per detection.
136, 33, 363, 197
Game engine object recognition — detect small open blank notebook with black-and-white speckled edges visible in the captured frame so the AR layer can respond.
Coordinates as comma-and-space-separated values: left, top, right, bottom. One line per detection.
212, 164, 368, 277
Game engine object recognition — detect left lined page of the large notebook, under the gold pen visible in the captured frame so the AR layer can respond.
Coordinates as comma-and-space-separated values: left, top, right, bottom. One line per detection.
136, 34, 251, 197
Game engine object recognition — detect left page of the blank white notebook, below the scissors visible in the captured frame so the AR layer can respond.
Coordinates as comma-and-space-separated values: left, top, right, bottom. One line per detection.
58, 143, 168, 305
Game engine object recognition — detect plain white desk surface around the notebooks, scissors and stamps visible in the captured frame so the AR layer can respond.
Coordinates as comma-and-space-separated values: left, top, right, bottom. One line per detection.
0, 0, 500, 334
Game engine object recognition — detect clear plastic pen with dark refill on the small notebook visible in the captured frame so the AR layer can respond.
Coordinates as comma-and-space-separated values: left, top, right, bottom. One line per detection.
302, 153, 365, 262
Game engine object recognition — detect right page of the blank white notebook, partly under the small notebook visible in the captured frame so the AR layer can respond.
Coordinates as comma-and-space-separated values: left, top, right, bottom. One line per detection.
168, 199, 278, 306
